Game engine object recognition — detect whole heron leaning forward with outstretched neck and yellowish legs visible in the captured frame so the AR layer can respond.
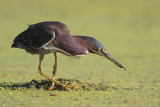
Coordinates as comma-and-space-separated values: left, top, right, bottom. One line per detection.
12, 21, 126, 90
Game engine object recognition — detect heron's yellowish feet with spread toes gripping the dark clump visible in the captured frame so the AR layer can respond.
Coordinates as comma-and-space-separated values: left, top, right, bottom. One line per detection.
48, 78, 82, 91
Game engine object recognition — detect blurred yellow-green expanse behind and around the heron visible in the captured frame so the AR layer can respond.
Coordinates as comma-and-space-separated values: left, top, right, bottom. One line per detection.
0, 0, 160, 104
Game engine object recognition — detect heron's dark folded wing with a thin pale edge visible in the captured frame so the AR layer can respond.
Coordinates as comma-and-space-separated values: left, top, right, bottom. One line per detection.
13, 27, 55, 48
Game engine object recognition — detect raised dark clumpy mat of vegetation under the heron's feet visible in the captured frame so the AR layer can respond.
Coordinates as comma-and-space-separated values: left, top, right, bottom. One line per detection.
0, 78, 118, 91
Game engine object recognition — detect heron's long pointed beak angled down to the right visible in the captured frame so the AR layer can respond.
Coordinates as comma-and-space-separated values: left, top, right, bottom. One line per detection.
98, 48, 126, 70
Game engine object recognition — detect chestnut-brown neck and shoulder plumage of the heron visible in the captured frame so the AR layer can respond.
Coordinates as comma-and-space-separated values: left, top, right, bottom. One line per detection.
47, 24, 88, 55
